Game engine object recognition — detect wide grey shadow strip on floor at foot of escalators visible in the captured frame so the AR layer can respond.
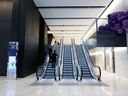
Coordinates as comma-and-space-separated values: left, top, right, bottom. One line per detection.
30, 79, 109, 87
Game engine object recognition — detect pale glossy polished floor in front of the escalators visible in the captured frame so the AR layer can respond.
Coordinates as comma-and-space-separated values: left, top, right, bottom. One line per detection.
0, 72, 128, 96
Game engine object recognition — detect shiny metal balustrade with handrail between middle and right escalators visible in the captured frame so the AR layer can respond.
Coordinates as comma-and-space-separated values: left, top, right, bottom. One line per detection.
72, 39, 82, 80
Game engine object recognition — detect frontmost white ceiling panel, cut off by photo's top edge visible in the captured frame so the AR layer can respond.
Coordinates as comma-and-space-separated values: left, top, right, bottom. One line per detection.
34, 0, 111, 6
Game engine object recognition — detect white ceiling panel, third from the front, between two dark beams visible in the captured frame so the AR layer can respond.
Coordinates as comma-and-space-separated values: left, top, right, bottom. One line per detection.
45, 19, 94, 25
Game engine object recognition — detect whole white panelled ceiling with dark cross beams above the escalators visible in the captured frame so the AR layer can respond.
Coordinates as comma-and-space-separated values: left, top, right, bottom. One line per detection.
34, 0, 112, 37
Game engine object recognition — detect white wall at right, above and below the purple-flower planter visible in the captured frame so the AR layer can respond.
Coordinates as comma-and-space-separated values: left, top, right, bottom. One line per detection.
84, 0, 128, 77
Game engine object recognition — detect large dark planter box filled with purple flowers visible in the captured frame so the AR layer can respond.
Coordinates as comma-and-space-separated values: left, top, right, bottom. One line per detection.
97, 11, 128, 47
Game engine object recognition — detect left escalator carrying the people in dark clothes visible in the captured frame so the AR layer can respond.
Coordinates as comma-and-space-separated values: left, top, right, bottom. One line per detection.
36, 39, 63, 80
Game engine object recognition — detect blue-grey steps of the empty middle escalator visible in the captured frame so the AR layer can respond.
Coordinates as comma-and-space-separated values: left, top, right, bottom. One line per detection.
62, 45, 74, 79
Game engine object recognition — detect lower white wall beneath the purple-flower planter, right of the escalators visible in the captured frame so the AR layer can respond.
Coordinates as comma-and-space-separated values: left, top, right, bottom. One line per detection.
89, 47, 128, 77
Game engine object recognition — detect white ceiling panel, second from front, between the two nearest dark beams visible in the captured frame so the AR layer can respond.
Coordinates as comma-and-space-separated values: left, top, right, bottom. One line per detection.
39, 8, 104, 18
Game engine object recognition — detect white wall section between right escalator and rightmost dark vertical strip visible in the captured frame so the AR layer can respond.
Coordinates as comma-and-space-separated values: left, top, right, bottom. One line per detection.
89, 47, 114, 72
